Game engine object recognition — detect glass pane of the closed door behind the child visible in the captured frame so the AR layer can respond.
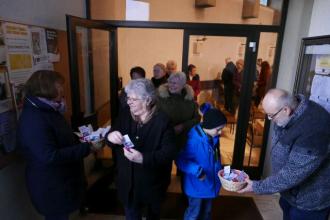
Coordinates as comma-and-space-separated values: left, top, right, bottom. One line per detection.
188, 35, 246, 164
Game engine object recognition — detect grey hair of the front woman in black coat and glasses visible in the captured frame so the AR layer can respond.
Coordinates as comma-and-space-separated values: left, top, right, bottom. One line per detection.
125, 78, 157, 103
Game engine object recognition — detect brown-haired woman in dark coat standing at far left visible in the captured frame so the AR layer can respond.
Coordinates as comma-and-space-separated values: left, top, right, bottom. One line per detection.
17, 70, 93, 220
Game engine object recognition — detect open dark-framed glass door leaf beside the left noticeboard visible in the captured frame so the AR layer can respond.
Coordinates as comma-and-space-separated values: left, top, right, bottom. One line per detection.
67, 16, 118, 129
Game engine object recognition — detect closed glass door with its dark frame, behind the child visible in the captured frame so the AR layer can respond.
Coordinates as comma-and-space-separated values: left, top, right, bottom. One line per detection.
182, 30, 263, 176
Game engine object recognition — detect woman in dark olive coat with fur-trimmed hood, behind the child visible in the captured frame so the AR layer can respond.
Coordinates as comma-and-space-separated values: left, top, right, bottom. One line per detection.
158, 72, 200, 150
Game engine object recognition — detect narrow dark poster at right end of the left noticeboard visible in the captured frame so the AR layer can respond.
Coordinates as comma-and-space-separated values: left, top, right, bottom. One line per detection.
46, 28, 60, 62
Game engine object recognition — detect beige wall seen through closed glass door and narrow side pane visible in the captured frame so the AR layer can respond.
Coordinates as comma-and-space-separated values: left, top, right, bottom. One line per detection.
188, 33, 277, 80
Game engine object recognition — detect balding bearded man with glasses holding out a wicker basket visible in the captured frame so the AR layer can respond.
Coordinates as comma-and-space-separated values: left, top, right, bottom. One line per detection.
239, 89, 330, 220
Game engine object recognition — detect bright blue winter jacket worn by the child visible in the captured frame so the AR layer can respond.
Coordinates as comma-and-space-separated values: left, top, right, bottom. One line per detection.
176, 124, 221, 198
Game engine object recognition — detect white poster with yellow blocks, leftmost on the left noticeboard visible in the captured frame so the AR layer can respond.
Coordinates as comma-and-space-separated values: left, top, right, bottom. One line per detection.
2, 22, 32, 85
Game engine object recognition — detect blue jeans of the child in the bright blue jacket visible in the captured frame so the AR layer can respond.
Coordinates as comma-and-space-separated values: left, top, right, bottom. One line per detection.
184, 196, 212, 220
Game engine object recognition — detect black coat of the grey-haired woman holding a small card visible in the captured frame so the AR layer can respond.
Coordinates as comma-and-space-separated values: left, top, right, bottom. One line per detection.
109, 108, 177, 205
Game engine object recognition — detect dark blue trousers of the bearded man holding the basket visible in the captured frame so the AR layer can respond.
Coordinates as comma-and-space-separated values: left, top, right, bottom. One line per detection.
279, 197, 330, 220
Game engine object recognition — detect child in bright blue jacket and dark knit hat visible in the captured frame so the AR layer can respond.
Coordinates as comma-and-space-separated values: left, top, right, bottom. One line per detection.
176, 108, 227, 220
